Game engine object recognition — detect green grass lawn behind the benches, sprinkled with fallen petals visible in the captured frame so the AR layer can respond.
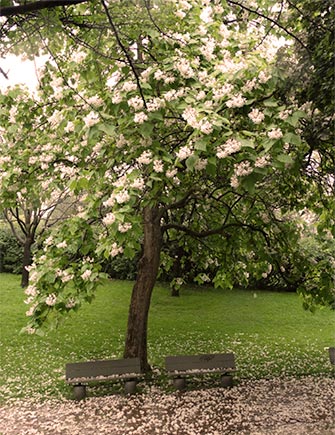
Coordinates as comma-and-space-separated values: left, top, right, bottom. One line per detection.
0, 274, 335, 401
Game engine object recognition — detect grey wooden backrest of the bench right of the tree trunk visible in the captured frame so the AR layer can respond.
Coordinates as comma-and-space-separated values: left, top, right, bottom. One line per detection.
165, 353, 235, 373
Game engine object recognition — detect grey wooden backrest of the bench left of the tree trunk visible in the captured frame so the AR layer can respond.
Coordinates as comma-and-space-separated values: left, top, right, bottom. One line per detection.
66, 358, 141, 380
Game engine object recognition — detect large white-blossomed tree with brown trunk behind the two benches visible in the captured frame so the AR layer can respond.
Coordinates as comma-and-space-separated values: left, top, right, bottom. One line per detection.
1, 1, 334, 369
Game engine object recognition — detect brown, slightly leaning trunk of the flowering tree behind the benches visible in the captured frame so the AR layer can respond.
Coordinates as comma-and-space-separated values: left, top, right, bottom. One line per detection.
124, 207, 162, 371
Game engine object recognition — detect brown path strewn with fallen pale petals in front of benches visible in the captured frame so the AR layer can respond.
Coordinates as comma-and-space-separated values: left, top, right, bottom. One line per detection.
0, 377, 335, 435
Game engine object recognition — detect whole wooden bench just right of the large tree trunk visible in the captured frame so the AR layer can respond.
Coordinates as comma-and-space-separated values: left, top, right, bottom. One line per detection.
165, 353, 236, 390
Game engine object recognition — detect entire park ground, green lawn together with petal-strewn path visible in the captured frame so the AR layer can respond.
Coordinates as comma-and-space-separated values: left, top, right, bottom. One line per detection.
0, 275, 335, 435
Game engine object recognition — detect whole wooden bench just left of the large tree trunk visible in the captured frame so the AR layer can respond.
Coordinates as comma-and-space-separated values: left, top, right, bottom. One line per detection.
66, 358, 143, 400
